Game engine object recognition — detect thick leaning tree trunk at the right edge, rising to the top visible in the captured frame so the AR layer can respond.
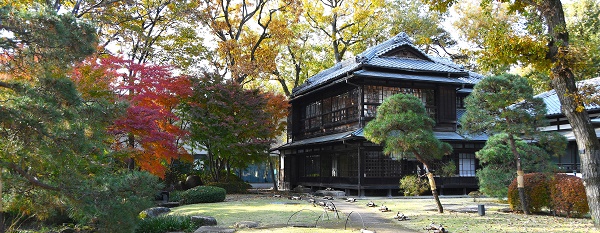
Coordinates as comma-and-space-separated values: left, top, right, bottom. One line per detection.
536, 0, 600, 226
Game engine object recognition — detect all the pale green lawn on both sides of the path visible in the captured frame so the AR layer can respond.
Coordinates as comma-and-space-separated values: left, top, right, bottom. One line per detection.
172, 195, 600, 233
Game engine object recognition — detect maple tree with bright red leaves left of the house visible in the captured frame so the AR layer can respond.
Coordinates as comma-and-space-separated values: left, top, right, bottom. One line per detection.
73, 56, 191, 177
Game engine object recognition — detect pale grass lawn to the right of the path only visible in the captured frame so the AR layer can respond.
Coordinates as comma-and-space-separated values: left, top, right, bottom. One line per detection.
357, 197, 600, 233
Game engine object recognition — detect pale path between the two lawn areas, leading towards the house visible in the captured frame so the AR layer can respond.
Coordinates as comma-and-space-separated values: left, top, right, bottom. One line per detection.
332, 198, 418, 233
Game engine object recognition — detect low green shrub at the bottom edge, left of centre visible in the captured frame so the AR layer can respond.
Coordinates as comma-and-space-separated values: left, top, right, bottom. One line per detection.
135, 215, 199, 233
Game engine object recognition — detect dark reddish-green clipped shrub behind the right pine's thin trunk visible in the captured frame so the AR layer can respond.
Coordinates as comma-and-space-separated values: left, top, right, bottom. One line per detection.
508, 173, 552, 212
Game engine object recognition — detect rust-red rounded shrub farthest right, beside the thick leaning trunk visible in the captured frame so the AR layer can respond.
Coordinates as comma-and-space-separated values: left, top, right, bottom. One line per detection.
550, 174, 590, 217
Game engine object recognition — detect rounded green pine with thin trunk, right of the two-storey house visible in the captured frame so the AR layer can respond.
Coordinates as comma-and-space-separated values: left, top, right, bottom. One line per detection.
461, 75, 564, 214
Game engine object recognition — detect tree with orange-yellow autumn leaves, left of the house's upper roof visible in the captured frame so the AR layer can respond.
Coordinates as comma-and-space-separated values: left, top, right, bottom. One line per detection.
195, 0, 299, 84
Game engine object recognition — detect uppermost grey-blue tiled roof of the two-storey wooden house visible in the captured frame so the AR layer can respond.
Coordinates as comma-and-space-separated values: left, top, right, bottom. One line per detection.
292, 33, 483, 96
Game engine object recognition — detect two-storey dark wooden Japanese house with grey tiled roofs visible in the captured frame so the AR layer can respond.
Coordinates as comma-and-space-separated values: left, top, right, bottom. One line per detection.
277, 33, 487, 196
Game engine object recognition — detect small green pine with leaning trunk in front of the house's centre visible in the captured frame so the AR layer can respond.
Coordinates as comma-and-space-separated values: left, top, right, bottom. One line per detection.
365, 94, 452, 213
